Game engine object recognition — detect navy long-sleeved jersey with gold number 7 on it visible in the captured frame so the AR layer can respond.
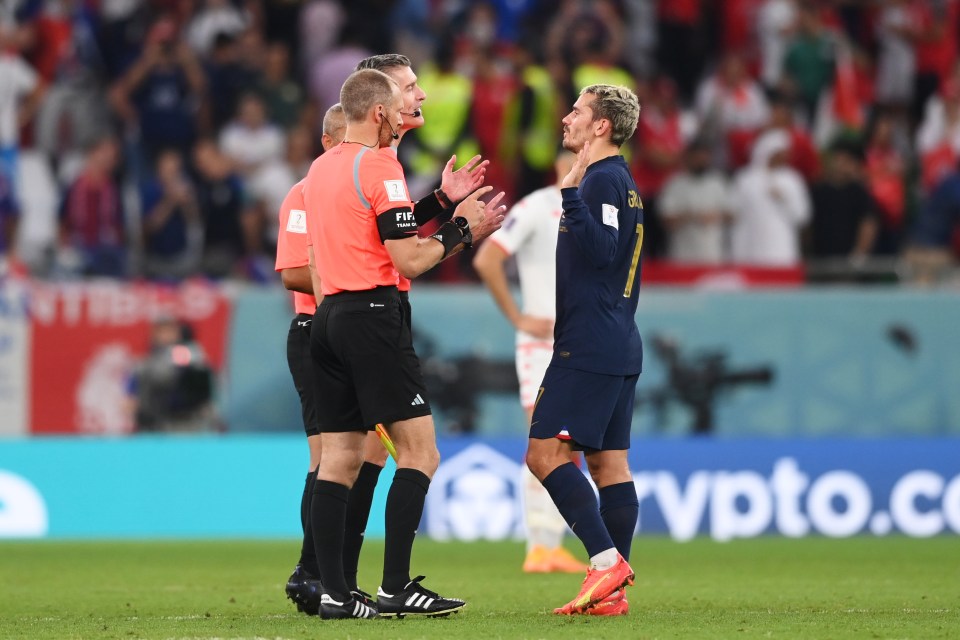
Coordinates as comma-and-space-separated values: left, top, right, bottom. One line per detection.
551, 156, 643, 375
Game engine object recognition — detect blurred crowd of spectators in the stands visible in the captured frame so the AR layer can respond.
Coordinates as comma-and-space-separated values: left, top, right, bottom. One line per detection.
0, 0, 960, 282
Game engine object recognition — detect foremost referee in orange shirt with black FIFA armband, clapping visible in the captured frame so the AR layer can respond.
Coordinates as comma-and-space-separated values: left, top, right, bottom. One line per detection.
303, 69, 505, 618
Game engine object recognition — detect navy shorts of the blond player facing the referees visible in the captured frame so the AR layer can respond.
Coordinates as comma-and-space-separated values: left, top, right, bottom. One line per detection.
530, 365, 640, 451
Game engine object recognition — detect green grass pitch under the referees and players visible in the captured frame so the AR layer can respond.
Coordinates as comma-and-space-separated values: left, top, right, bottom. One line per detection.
0, 537, 960, 640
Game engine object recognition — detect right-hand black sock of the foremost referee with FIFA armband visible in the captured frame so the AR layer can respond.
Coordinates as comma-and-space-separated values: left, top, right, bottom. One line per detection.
381, 468, 430, 595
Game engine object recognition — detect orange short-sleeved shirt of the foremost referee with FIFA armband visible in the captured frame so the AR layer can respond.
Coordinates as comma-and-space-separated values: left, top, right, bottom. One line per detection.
303, 142, 417, 295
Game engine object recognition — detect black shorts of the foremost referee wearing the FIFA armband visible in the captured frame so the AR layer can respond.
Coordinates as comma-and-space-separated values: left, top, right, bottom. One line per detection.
310, 287, 430, 432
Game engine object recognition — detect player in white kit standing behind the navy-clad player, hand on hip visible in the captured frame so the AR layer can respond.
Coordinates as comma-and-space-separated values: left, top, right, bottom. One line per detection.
473, 151, 586, 573
